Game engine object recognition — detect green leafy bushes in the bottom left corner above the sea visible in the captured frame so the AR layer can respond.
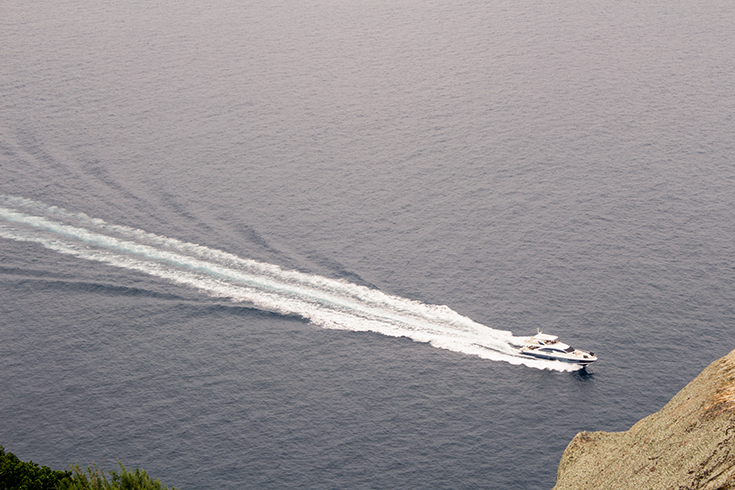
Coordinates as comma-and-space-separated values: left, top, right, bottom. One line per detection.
0, 446, 176, 490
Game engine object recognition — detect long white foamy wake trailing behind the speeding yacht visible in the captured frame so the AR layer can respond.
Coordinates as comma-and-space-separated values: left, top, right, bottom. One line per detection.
0, 195, 578, 371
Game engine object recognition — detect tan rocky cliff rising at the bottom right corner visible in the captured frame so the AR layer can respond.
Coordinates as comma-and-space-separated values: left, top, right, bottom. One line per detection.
554, 351, 735, 490
